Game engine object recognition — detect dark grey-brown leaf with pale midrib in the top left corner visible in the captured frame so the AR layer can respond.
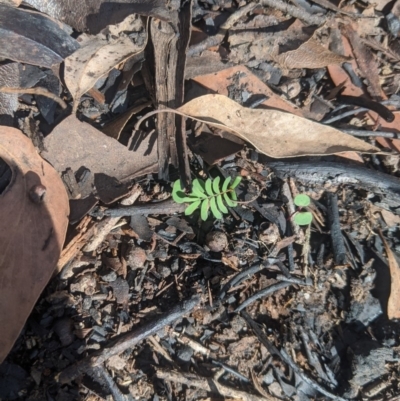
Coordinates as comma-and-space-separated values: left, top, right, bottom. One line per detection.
0, 3, 79, 68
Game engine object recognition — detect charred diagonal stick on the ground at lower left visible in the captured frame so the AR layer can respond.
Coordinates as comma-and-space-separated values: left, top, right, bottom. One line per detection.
57, 296, 200, 384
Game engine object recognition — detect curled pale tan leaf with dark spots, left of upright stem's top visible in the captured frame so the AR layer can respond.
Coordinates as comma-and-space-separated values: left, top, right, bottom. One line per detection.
64, 16, 146, 110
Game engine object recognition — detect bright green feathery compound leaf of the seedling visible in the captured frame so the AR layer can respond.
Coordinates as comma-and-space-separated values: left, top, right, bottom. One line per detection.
172, 176, 242, 221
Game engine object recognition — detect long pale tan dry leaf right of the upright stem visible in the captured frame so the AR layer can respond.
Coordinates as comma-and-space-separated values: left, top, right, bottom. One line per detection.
169, 95, 379, 158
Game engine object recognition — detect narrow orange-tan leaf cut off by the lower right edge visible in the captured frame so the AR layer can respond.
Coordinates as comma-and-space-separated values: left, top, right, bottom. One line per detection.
378, 229, 400, 320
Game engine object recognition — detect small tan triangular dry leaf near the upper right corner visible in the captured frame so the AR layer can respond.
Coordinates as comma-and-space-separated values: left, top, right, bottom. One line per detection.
274, 37, 349, 69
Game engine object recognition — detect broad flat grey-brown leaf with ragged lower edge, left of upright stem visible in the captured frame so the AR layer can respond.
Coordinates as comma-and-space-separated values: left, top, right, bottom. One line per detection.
42, 115, 157, 188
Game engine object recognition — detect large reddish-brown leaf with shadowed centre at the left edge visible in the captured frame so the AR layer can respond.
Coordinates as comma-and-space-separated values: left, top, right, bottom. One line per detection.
0, 127, 69, 363
